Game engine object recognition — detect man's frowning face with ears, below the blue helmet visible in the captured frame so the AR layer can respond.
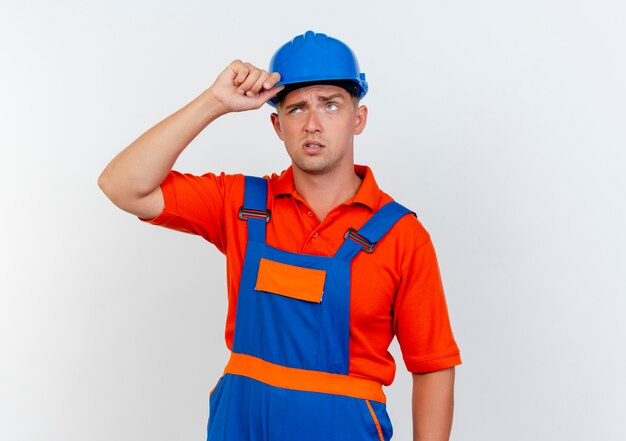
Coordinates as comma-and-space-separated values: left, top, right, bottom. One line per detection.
272, 85, 367, 174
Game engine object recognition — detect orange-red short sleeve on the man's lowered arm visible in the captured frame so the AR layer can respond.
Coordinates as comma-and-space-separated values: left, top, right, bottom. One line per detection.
394, 222, 461, 373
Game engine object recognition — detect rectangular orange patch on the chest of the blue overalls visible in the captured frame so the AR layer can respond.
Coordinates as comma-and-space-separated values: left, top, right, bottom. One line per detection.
255, 258, 326, 303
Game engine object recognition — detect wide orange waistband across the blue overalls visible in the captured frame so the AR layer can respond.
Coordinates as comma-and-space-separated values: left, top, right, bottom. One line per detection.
224, 352, 386, 403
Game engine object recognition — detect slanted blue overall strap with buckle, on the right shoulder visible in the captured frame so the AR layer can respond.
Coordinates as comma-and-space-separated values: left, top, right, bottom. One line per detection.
335, 201, 415, 260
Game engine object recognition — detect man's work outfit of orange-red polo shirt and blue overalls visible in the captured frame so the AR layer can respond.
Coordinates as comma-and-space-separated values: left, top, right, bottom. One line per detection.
149, 166, 460, 440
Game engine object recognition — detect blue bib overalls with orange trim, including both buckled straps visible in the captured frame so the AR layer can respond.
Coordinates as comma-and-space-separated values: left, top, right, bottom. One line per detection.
207, 177, 410, 441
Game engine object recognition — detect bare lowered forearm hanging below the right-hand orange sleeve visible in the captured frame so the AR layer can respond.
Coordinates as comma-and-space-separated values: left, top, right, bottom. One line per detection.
413, 368, 454, 441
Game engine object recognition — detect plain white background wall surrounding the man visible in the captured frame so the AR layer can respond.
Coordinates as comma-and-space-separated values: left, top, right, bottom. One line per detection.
0, 0, 626, 441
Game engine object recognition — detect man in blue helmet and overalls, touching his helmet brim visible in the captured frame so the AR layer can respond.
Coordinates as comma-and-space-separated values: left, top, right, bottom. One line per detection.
99, 31, 460, 441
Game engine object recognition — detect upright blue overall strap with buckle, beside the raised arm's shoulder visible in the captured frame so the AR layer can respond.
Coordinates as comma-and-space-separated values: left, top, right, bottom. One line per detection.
239, 176, 271, 243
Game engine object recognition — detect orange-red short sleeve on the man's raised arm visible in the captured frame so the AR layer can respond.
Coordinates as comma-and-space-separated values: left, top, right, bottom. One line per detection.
141, 171, 243, 253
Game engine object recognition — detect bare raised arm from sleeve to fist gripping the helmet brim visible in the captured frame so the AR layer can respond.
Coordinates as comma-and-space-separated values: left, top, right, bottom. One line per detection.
98, 60, 282, 219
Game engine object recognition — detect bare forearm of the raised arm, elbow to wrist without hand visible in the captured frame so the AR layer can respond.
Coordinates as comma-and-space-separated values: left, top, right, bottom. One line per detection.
98, 89, 223, 211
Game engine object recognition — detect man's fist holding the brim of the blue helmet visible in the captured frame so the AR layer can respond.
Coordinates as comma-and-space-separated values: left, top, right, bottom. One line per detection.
209, 60, 284, 112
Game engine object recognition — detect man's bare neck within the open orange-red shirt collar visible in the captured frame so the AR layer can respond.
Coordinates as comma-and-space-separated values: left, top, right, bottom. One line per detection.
293, 164, 361, 221
